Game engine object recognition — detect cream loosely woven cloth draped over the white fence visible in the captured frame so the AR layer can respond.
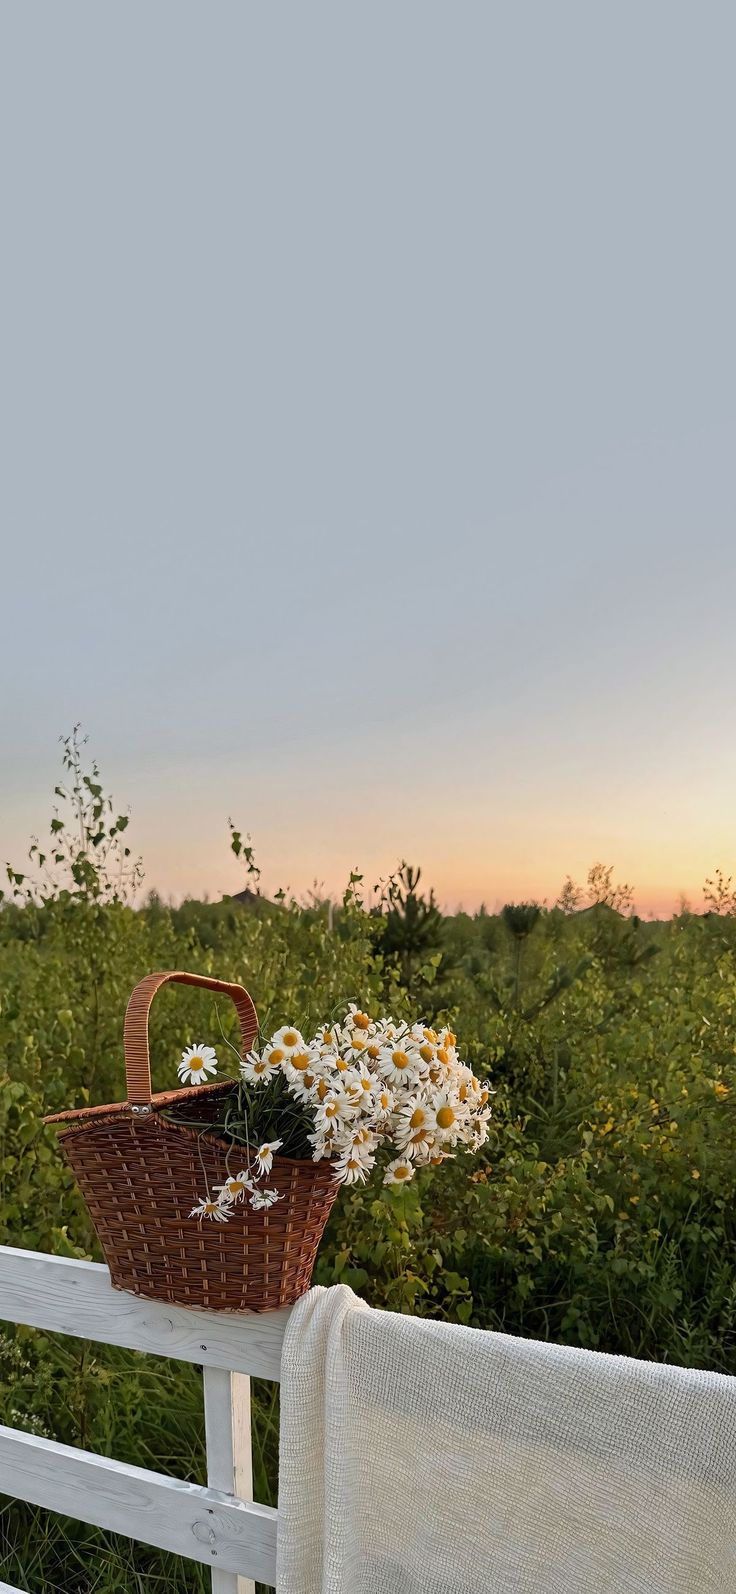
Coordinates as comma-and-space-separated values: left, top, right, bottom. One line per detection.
277, 1285, 736, 1594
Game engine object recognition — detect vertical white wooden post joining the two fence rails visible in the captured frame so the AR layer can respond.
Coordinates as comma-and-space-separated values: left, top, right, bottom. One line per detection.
202, 1368, 255, 1594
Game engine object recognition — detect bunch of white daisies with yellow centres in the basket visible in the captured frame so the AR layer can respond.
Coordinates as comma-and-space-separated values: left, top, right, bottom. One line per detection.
177, 1004, 492, 1223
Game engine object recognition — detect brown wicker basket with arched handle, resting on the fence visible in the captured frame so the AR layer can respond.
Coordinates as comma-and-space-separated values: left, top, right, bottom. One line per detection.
46, 972, 336, 1312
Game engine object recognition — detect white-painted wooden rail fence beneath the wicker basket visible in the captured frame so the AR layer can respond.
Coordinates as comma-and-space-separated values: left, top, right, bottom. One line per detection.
0, 1247, 290, 1594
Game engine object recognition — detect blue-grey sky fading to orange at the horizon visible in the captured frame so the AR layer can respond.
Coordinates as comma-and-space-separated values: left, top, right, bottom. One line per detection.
0, 0, 736, 912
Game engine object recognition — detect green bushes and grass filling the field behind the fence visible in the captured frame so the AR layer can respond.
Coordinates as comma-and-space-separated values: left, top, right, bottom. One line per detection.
0, 752, 736, 1594
